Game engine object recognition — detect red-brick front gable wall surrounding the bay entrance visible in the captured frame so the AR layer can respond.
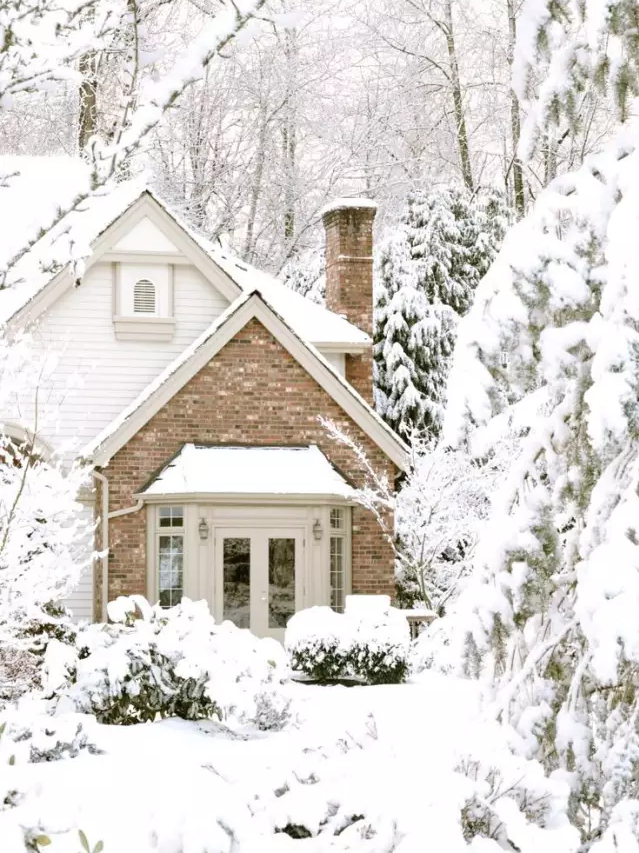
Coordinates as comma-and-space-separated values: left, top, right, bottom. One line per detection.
96, 319, 394, 599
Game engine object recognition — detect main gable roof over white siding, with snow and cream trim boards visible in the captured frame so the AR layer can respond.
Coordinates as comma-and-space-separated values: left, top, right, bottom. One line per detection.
0, 157, 371, 352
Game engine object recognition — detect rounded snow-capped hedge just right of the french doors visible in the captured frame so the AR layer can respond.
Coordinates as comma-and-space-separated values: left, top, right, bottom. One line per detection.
284, 607, 410, 684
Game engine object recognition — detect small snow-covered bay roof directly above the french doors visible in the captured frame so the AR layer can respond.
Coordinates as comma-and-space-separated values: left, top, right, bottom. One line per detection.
142, 444, 354, 499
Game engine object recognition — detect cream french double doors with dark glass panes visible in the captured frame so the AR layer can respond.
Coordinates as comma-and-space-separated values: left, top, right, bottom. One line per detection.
213, 527, 304, 640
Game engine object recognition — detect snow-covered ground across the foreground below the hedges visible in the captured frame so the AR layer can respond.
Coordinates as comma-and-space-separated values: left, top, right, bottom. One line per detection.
0, 673, 576, 853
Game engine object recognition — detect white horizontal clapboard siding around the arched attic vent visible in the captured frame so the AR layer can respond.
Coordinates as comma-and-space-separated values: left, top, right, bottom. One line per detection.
0, 263, 228, 618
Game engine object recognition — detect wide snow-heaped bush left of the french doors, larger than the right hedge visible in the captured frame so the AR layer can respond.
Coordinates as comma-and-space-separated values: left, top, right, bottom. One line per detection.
45, 596, 288, 728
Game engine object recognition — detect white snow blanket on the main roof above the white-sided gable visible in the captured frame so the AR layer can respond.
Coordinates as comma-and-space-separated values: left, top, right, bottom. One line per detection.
0, 156, 371, 350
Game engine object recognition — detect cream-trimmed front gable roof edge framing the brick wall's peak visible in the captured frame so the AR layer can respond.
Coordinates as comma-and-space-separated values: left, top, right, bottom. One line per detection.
81, 289, 408, 470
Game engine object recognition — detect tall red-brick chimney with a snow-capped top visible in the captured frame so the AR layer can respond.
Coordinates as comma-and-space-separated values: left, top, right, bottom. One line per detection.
322, 199, 377, 404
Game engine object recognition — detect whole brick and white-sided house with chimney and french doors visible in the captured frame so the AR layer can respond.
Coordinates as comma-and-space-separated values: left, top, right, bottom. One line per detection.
3, 161, 406, 637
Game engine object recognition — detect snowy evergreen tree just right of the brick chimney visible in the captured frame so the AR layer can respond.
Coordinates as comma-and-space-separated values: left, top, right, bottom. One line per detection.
374, 186, 508, 436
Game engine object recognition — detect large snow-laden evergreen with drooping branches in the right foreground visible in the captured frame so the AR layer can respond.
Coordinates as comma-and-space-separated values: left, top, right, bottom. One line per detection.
435, 0, 639, 852
